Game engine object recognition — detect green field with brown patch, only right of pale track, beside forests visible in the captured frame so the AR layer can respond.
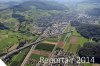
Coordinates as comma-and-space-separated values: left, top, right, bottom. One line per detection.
69, 27, 88, 53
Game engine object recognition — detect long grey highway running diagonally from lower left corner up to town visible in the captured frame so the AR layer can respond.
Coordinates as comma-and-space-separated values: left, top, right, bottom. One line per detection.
0, 27, 50, 61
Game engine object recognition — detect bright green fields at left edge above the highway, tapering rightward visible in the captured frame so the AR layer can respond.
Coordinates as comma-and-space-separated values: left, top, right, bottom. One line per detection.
0, 30, 38, 52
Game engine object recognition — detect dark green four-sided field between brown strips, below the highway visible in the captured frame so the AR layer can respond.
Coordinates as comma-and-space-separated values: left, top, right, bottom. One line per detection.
35, 43, 55, 51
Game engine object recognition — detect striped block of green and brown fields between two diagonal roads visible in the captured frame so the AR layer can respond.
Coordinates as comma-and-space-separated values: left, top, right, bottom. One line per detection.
25, 38, 58, 66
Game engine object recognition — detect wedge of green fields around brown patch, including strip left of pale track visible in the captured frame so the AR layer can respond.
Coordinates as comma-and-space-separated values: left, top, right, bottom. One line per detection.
62, 26, 89, 53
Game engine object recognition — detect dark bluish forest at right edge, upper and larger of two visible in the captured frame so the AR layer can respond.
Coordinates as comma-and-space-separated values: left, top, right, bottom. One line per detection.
72, 21, 100, 42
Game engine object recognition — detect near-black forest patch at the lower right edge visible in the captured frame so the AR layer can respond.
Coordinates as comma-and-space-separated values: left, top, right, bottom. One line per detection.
78, 42, 100, 63
